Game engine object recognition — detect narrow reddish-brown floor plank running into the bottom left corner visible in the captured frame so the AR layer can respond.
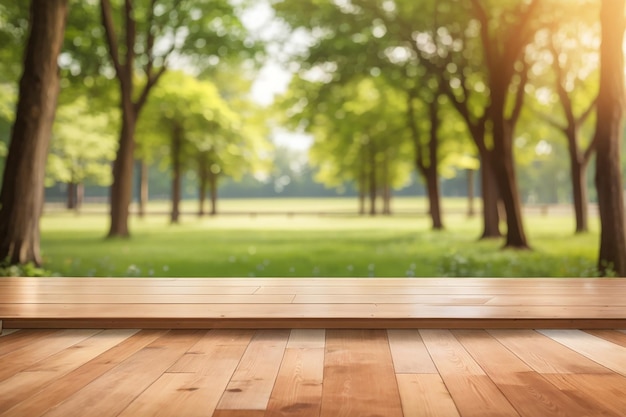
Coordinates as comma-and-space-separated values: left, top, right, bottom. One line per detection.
0, 330, 165, 417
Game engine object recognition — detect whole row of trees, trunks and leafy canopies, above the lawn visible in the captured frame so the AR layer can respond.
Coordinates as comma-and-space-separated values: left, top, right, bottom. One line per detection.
0, 0, 626, 275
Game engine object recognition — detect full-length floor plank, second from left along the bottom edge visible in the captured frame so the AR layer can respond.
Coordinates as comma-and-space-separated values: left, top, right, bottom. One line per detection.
36, 330, 204, 417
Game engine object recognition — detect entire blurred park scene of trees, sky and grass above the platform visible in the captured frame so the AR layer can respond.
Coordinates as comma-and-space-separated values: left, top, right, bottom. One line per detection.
0, 0, 626, 277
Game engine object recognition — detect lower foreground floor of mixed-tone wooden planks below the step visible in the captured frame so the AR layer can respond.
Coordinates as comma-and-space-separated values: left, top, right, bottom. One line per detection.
0, 329, 626, 417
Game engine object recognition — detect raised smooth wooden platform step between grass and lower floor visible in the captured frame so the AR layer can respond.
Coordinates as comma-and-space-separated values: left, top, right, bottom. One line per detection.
0, 278, 626, 329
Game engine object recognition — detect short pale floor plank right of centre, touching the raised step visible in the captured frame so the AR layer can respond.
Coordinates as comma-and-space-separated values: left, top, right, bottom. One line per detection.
387, 329, 437, 374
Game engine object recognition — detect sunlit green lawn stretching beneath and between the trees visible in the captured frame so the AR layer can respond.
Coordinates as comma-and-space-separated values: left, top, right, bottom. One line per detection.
41, 199, 598, 277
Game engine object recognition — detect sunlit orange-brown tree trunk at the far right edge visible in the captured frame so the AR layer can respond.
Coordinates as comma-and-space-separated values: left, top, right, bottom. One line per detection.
594, 0, 626, 277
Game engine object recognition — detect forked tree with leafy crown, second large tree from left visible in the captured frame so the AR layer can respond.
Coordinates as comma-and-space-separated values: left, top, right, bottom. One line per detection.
100, 0, 254, 237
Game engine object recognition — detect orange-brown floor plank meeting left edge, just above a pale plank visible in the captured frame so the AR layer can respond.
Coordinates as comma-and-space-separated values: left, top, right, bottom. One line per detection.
0, 329, 101, 381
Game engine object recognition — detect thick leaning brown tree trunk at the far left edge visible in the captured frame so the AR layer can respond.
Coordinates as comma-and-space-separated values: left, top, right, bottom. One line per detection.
0, 0, 67, 265
